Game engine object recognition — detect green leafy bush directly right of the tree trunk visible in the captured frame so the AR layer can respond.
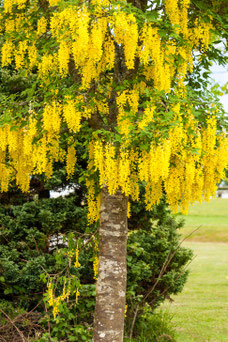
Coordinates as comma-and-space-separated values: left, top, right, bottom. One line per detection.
125, 200, 192, 332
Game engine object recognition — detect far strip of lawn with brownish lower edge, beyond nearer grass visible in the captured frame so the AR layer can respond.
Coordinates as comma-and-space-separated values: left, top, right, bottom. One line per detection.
178, 198, 228, 243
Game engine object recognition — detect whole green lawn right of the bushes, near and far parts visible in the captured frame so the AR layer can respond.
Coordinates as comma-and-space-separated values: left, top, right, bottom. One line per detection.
164, 199, 228, 342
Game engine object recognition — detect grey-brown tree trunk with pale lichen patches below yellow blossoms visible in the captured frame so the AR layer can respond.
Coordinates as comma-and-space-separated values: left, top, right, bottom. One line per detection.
93, 187, 128, 342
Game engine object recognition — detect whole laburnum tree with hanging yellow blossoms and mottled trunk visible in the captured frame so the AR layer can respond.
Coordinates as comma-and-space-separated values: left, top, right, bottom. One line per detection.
0, 0, 227, 342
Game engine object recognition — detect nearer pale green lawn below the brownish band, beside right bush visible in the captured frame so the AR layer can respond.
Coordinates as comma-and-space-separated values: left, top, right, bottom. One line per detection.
164, 242, 228, 342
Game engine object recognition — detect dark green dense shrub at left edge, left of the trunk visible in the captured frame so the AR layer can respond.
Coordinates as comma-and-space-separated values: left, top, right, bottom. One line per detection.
0, 192, 91, 306
